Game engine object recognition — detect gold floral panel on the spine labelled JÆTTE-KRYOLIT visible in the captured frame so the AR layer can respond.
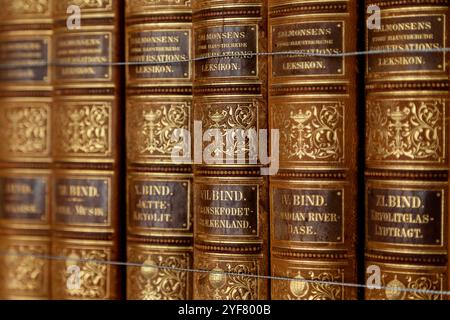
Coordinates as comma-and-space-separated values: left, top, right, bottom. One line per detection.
127, 102, 190, 159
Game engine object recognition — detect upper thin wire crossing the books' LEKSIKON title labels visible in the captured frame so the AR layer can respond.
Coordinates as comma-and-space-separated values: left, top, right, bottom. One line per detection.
0, 48, 450, 69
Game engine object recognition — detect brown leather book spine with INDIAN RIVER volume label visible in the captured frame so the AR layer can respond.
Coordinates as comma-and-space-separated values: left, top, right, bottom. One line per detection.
268, 0, 358, 300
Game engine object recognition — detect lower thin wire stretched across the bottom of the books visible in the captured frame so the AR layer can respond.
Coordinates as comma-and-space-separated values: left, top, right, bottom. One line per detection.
0, 251, 450, 296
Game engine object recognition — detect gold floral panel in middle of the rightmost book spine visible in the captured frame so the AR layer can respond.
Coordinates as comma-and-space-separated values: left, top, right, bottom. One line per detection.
366, 100, 445, 162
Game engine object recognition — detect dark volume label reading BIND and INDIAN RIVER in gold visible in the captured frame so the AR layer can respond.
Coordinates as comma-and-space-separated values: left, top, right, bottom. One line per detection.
272, 189, 344, 242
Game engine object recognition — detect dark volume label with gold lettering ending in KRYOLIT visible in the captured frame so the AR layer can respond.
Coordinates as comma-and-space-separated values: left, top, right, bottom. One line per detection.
128, 180, 189, 230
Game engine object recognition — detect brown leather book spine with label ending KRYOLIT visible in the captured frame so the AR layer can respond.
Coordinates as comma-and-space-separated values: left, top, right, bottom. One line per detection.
125, 0, 193, 300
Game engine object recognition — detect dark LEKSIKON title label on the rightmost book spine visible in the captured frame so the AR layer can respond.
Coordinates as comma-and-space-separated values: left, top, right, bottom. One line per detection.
367, 14, 445, 73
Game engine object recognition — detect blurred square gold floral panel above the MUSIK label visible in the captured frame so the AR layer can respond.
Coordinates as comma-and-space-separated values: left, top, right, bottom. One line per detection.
55, 103, 111, 154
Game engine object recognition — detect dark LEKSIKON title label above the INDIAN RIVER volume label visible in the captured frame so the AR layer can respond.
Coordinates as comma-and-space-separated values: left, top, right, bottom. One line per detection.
272, 21, 344, 77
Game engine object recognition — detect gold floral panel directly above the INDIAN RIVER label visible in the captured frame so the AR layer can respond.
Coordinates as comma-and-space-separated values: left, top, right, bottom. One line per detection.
273, 102, 344, 161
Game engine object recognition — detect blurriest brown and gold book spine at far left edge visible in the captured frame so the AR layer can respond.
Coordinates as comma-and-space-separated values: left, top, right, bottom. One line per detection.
0, 0, 53, 299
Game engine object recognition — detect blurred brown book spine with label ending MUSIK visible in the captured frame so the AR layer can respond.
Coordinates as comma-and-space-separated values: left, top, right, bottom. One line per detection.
52, 0, 124, 300
